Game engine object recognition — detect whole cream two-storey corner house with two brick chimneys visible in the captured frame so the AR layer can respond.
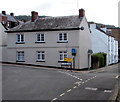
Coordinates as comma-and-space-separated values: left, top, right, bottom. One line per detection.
7, 9, 91, 69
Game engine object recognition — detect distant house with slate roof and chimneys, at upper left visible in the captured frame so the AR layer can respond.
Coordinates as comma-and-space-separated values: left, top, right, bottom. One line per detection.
0, 11, 19, 29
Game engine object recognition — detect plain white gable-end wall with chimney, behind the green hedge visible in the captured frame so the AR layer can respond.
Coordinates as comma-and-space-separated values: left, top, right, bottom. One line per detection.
90, 24, 108, 65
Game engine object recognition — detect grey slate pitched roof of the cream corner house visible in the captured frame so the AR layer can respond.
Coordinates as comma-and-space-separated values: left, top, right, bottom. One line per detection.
10, 15, 82, 31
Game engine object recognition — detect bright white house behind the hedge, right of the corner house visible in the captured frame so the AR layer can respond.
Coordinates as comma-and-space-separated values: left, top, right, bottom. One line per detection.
90, 23, 118, 65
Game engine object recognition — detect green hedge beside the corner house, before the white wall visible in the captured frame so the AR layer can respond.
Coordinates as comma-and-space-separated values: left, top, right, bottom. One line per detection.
91, 52, 107, 68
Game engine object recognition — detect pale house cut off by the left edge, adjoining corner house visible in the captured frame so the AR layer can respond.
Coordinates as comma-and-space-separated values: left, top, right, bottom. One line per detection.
0, 22, 7, 62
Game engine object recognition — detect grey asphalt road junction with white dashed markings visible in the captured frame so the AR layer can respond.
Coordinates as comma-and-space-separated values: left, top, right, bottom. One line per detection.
2, 64, 119, 102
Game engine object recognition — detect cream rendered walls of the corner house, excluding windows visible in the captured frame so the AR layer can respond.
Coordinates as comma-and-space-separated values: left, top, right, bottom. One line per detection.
7, 17, 91, 69
